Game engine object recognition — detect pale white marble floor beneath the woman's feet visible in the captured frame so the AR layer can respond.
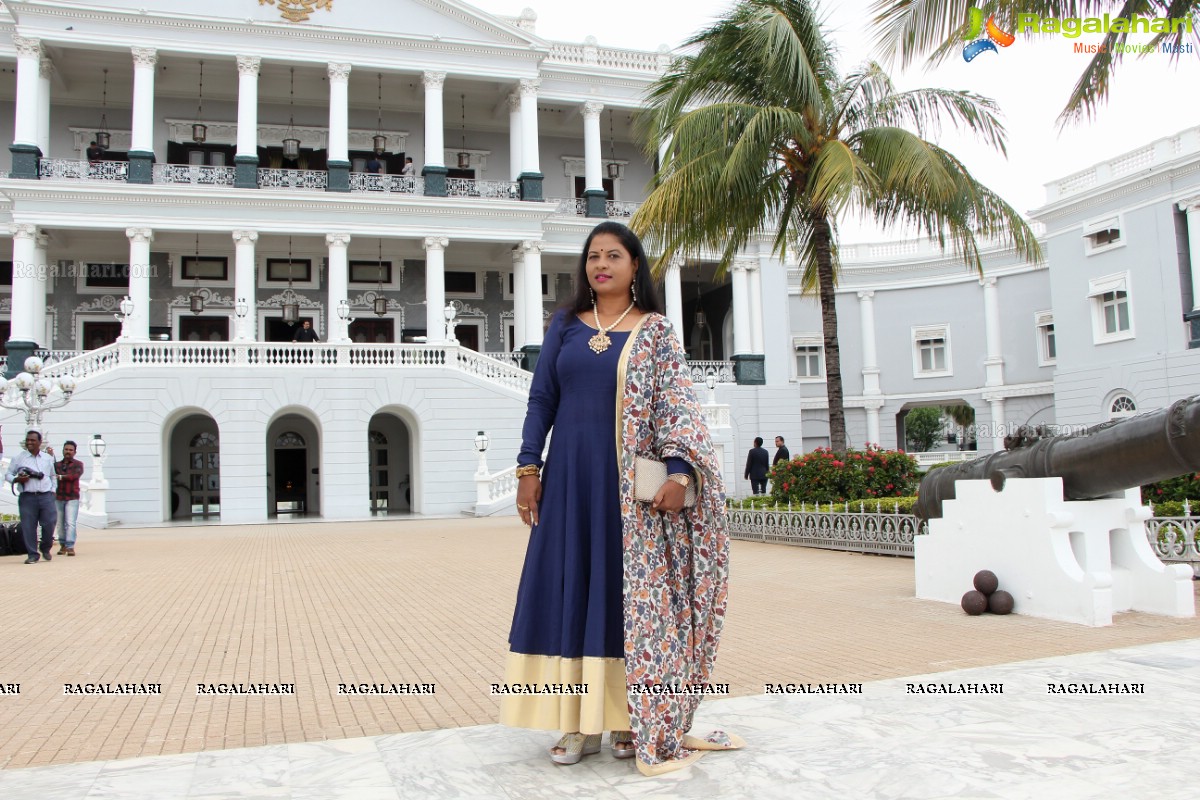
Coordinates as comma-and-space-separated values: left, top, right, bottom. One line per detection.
0, 639, 1200, 800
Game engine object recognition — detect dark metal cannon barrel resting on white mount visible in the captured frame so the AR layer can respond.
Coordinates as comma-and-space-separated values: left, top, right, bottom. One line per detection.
913, 395, 1200, 519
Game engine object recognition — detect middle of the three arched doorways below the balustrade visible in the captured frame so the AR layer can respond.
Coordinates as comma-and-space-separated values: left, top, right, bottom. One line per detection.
266, 414, 320, 517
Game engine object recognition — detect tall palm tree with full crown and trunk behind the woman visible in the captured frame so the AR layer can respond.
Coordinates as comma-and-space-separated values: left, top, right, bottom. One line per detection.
631, 0, 1040, 450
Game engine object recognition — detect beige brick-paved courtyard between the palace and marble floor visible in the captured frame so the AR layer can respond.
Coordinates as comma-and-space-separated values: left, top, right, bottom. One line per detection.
0, 518, 1200, 777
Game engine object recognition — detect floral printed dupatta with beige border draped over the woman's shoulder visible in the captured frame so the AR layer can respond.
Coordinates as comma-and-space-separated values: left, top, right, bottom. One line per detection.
617, 314, 730, 765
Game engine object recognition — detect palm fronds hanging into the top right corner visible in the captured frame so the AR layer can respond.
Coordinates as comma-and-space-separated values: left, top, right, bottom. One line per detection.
871, 0, 1200, 125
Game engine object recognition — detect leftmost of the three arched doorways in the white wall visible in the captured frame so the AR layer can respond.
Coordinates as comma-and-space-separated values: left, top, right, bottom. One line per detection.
168, 414, 221, 519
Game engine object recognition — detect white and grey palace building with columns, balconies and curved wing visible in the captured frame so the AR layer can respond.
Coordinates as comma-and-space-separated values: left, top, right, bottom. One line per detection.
0, 0, 1200, 525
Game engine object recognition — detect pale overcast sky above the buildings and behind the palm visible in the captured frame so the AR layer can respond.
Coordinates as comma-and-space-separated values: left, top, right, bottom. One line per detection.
468, 0, 1200, 240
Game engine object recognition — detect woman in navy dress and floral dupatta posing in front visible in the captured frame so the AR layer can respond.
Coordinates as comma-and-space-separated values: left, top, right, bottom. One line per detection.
500, 222, 740, 775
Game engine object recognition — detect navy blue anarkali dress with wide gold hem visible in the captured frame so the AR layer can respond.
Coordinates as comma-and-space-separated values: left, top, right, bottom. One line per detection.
500, 312, 629, 733
